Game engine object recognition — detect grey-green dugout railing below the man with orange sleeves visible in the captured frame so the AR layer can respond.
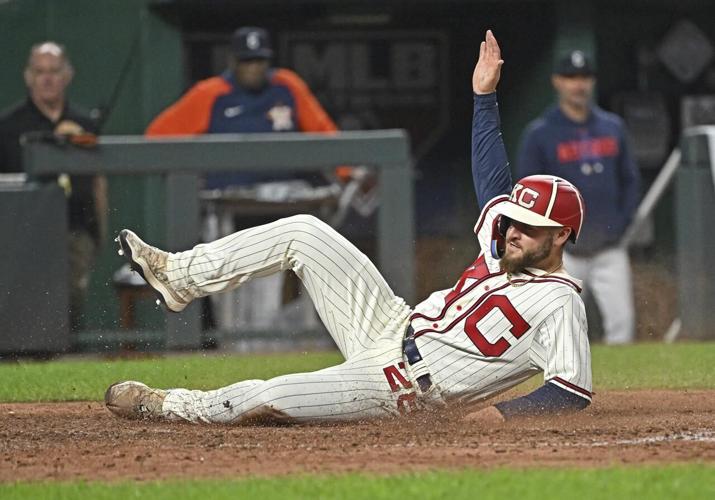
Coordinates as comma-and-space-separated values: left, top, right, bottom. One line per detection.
23, 130, 415, 349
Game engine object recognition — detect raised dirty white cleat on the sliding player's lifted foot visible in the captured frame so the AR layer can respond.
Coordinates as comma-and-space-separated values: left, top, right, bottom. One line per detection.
117, 229, 191, 312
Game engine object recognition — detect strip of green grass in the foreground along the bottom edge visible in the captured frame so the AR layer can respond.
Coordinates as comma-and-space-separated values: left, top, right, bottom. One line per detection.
0, 465, 715, 500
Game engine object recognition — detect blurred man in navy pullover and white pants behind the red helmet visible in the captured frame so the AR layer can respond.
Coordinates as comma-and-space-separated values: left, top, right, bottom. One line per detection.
517, 50, 640, 344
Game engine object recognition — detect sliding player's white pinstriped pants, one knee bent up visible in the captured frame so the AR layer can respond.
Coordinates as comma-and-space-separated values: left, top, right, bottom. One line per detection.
158, 215, 410, 423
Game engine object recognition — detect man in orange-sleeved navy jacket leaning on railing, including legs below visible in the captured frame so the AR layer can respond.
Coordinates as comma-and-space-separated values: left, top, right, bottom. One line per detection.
146, 26, 353, 328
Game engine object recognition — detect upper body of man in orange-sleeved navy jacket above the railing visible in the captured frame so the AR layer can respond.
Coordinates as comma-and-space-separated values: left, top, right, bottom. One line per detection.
146, 27, 350, 188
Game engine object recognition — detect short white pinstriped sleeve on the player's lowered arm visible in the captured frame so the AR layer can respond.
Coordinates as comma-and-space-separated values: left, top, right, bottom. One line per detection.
532, 292, 592, 401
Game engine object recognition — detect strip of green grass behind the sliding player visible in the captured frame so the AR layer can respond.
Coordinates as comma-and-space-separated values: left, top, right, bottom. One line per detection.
0, 342, 715, 402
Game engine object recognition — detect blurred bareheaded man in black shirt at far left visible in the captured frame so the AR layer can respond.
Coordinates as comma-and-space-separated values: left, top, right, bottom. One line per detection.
0, 42, 107, 330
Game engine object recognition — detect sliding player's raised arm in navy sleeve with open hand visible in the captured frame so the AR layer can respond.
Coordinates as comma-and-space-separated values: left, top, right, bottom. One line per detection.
472, 30, 512, 208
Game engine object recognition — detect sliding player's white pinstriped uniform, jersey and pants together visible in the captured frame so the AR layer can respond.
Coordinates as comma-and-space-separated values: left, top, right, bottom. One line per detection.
163, 201, 591, 423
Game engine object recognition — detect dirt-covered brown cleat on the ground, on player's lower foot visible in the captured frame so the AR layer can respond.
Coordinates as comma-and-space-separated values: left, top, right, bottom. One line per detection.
104, 380, 166, 419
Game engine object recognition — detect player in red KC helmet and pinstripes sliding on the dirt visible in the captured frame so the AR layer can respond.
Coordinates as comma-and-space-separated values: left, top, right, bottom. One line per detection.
105, 31, 591, 425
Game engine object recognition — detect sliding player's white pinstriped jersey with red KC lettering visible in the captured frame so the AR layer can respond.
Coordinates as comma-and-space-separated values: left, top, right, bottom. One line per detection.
410, 196, 591, 402
